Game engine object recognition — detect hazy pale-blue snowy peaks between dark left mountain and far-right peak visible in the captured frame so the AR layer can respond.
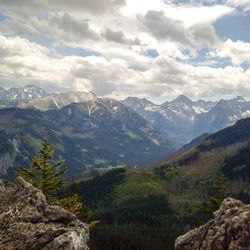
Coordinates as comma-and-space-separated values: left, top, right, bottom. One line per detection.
123, 95, 215, 146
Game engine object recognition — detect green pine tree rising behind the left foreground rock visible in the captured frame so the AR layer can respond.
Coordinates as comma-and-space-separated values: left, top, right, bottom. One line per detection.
19, 140, 66, 199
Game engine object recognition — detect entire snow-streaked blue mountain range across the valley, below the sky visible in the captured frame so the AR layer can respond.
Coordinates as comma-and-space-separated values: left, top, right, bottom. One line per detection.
0, 85, 250, 178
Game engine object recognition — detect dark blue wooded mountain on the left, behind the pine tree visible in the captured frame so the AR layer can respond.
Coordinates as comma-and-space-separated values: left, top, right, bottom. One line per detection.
0, 99, 173, 176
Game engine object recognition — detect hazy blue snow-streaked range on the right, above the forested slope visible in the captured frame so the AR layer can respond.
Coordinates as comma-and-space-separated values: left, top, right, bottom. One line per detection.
123, 95, 250, 147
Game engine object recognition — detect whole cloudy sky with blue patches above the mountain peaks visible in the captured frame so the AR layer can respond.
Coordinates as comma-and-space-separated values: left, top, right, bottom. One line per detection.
0, 0, 250, 102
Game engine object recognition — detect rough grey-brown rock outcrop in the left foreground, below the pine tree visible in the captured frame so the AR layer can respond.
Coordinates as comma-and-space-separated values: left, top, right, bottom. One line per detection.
0, 177, 89, 250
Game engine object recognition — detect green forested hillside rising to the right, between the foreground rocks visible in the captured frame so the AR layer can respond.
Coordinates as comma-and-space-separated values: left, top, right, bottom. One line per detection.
69, 119, 250, 250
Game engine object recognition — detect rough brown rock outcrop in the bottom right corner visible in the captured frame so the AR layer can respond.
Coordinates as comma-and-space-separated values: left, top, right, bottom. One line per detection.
175, 198, 250, 250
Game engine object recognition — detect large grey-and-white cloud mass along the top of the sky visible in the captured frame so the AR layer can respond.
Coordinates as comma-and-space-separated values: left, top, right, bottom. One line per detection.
0, 0, 233, 54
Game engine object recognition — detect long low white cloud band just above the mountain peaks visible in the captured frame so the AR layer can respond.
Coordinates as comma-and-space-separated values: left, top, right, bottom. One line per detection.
0, 36, 250, 97
